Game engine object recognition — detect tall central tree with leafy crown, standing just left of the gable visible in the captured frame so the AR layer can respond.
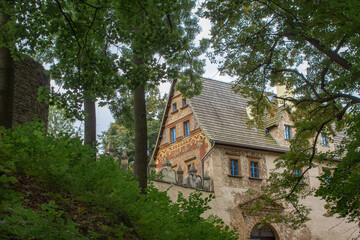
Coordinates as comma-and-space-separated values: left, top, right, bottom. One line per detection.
109, 0, 203, 191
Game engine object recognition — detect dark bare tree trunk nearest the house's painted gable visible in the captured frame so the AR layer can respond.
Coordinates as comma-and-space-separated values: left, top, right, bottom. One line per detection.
133, 84, 147, 193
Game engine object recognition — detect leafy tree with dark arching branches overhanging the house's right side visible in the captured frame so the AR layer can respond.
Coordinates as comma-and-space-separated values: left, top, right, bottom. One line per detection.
201, 0, 360, 227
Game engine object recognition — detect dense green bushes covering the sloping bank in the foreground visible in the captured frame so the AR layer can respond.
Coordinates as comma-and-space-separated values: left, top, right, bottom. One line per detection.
0, 121, 237, 240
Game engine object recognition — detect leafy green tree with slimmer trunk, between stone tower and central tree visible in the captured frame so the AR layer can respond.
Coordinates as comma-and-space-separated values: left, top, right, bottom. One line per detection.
0, 0, 121, 150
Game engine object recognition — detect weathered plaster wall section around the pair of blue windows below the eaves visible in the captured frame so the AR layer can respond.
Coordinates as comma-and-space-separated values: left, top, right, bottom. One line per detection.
204, 146, 282, 228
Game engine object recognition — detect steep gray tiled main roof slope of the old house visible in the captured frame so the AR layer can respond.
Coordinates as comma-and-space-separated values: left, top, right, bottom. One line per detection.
189, 79, 287, 151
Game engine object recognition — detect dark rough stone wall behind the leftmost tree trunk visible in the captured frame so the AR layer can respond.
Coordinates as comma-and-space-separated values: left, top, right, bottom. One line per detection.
13, 58, 50, 124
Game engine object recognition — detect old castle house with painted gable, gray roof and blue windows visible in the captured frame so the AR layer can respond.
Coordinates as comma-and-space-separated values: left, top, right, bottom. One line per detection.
150, 79, 359, 240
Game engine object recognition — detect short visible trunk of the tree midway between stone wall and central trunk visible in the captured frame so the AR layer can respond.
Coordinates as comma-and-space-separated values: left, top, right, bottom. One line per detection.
84, 98, 96, 149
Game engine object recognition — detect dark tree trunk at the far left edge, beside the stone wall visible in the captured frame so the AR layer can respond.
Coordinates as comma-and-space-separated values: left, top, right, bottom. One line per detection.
0, 12, 15, 128
